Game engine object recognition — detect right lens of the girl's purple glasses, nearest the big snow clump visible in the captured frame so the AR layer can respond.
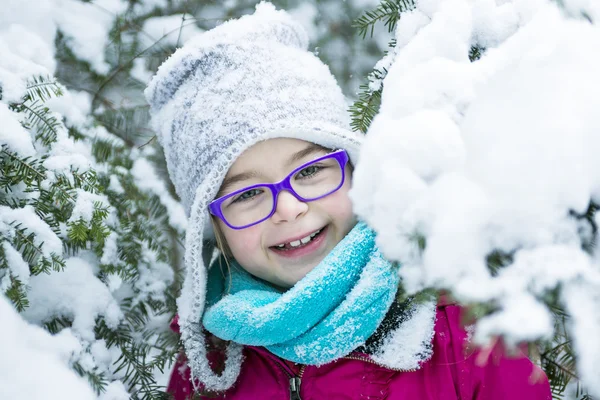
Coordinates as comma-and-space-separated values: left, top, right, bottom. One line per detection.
290, 158, 342, 200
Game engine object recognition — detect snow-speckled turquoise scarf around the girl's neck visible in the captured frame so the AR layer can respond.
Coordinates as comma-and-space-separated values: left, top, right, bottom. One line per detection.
203, 222, 399, 365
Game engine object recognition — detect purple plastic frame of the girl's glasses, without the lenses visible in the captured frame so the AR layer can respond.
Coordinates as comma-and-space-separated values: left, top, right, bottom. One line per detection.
208, 150, 349, 230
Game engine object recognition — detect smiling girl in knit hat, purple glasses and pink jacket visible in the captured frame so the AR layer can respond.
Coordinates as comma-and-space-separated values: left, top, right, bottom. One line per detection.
146, 3, 551, 400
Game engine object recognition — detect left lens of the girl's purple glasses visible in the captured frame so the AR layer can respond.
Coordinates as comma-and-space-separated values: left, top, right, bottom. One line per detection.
221, 186, 273, 228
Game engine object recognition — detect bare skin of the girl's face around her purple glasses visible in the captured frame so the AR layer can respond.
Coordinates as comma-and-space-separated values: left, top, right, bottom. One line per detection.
217, 138, 356, 289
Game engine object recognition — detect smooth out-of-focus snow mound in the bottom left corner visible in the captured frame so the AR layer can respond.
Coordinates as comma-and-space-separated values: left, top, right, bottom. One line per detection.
0, 296, 96, 400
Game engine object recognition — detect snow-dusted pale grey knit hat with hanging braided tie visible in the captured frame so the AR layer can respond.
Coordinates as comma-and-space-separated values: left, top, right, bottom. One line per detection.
145, 2, 362, 390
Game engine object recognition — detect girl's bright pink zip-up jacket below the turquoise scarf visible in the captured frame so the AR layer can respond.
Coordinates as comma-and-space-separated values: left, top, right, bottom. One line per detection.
167, 305, 552, 400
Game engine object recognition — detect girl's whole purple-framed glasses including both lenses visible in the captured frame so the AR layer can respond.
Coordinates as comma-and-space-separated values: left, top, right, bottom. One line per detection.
208, 150, 348, 229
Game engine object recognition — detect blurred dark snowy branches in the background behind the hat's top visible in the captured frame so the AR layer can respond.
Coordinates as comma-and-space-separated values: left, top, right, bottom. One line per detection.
56, 0, 392, 145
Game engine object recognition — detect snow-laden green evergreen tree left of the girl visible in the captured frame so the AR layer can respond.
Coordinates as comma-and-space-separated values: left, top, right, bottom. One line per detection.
0, 2, 186, 399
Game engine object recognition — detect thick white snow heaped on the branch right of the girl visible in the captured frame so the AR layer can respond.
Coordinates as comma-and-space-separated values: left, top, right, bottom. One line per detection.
351, 0, 600, 394
